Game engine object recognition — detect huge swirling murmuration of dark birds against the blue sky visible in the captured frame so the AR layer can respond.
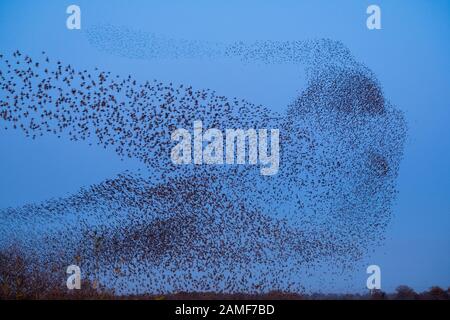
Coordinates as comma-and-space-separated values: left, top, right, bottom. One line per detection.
0, 34, 406, 293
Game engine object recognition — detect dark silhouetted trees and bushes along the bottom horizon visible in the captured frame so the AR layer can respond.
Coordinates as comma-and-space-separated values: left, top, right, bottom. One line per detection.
0, 248, 450, 300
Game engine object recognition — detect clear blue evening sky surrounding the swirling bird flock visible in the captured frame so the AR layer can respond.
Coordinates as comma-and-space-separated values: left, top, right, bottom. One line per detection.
0, 0, 450, 291
